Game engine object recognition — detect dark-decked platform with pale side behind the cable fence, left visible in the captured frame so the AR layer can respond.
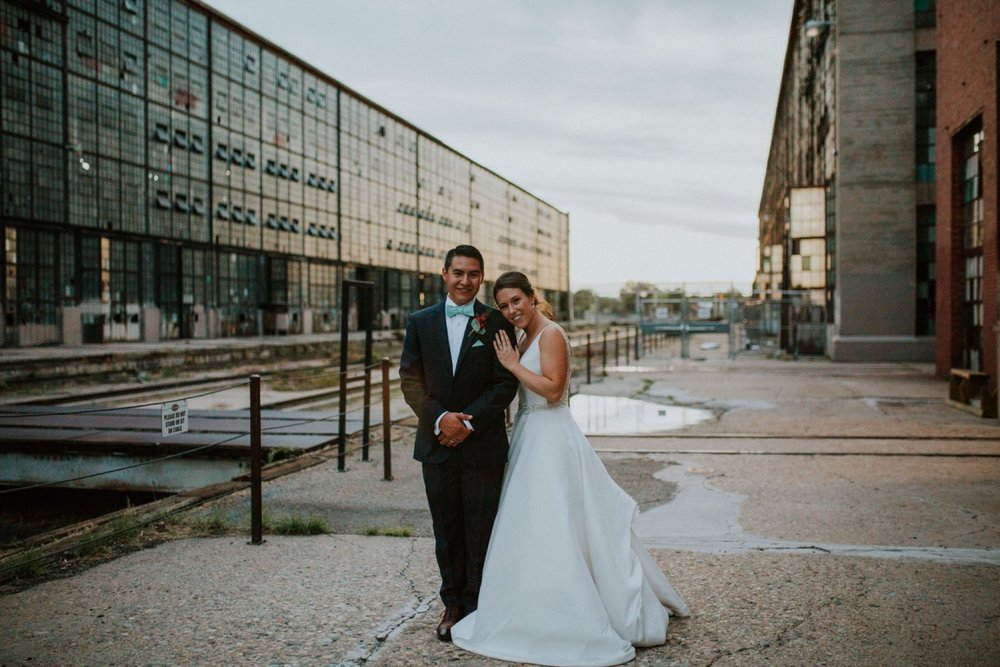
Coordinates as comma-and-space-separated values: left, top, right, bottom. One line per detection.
0, 405, 382, 493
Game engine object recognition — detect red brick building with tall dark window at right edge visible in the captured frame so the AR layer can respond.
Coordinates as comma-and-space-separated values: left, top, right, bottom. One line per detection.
937, 0, 1000, 395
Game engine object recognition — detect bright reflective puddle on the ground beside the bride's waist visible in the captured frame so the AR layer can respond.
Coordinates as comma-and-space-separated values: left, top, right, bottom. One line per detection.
569, 394, 712, 435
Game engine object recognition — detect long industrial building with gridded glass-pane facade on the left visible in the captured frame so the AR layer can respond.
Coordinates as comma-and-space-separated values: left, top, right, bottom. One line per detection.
0, 0, 570, 345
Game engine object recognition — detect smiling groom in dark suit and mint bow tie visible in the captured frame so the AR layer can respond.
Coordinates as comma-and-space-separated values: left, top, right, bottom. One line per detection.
399, 245, 517, 641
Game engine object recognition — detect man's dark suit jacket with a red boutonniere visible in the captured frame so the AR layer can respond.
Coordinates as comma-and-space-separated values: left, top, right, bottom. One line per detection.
399, 300, 517, 466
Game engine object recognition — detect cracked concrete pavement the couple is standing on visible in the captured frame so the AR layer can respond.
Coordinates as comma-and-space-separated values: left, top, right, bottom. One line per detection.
0, 346, 1000, 665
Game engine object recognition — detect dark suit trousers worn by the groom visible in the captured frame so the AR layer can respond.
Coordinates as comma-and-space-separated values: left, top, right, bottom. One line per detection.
423, 456, 505, 613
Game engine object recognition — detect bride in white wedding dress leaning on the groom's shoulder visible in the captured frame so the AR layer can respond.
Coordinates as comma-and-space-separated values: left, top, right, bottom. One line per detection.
451, 271, 688, 667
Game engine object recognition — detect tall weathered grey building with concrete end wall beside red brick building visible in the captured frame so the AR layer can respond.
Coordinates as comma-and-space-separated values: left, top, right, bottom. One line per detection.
755, 0, 937, 361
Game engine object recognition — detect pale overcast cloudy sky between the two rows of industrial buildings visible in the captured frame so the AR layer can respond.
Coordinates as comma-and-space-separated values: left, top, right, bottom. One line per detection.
208, 0, 792, 294
